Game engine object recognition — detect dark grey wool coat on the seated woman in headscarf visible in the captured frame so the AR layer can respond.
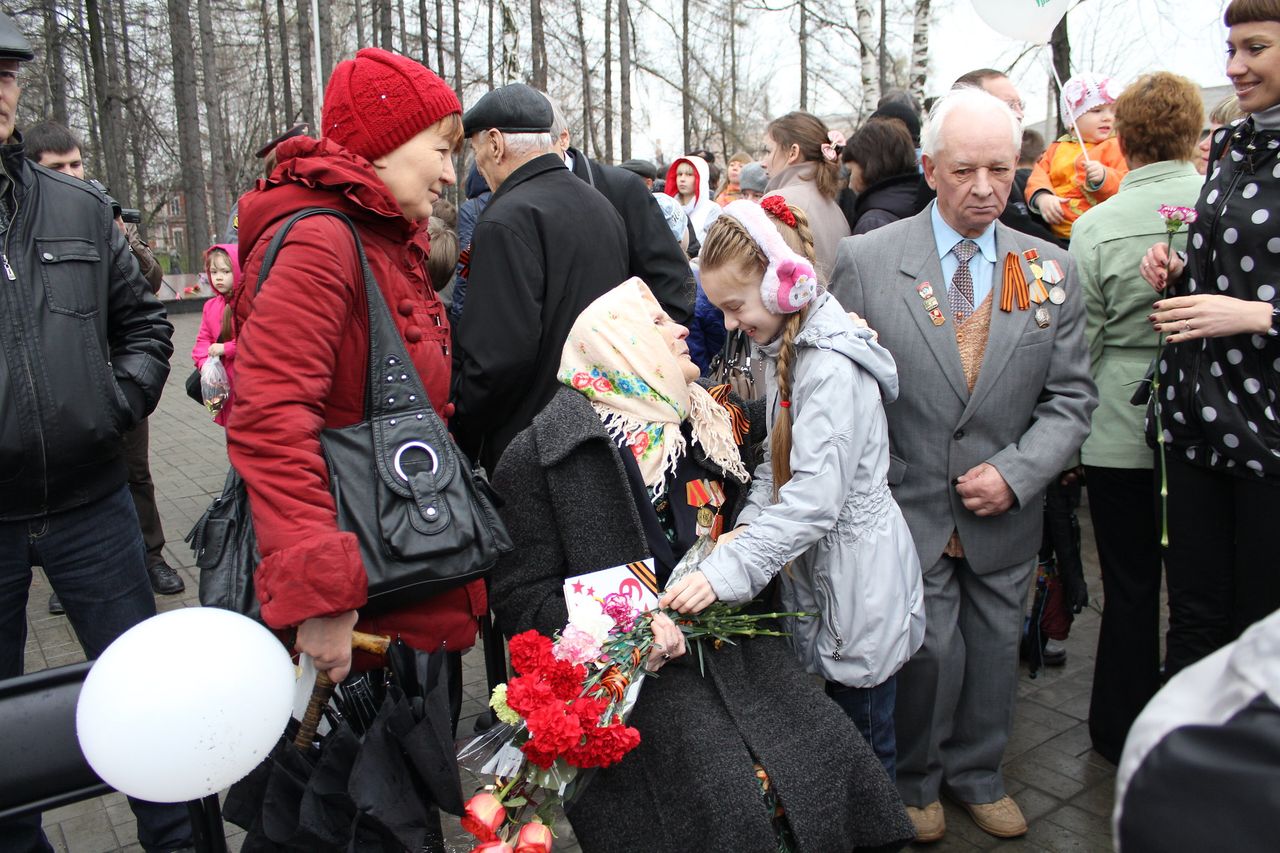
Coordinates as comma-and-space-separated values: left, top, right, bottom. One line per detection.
489, 388, 914, 853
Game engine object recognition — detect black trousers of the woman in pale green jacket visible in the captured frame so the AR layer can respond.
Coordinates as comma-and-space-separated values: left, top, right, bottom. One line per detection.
1084, 465, 1161, 763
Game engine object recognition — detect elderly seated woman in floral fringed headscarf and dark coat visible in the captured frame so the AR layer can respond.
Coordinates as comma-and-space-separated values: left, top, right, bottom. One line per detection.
490, 278, 913, 853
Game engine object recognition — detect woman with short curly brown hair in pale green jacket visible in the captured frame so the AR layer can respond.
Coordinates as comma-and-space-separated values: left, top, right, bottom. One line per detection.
1071, 72, 1203, 763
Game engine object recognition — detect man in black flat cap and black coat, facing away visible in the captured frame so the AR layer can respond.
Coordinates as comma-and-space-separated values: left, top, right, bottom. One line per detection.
452, 83, 627, 471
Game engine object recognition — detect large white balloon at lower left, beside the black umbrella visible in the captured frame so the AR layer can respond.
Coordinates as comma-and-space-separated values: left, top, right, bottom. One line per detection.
76, 607, 294, 803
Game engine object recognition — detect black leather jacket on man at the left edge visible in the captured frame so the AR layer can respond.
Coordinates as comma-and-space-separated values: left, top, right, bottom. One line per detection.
0, 134, 173, 520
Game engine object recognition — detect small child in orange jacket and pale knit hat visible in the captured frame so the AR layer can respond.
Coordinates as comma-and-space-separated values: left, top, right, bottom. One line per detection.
1027, 72, 1129, 241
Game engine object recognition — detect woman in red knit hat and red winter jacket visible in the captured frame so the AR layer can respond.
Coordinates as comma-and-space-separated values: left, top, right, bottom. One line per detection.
227, 47, 486, 681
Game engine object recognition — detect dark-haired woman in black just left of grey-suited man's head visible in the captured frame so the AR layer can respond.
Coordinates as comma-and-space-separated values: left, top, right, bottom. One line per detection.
840, 119, 920, 234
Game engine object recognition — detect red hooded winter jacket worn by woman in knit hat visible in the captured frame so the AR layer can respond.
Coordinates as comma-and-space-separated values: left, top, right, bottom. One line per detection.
227, 137, 486, 651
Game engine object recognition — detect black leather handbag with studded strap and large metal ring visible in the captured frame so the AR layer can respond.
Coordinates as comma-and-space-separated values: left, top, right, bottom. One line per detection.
189, 207, 512, 612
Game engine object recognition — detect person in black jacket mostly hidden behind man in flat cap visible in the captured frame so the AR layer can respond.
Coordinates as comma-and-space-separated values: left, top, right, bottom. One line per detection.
547, 96, 695, 325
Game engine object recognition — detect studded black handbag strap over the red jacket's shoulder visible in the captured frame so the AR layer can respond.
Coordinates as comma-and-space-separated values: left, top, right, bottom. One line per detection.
256, 207, 444, 429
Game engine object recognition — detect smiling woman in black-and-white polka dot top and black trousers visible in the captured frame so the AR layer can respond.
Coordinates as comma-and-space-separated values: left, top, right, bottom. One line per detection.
1142, 0, 1280, 676
